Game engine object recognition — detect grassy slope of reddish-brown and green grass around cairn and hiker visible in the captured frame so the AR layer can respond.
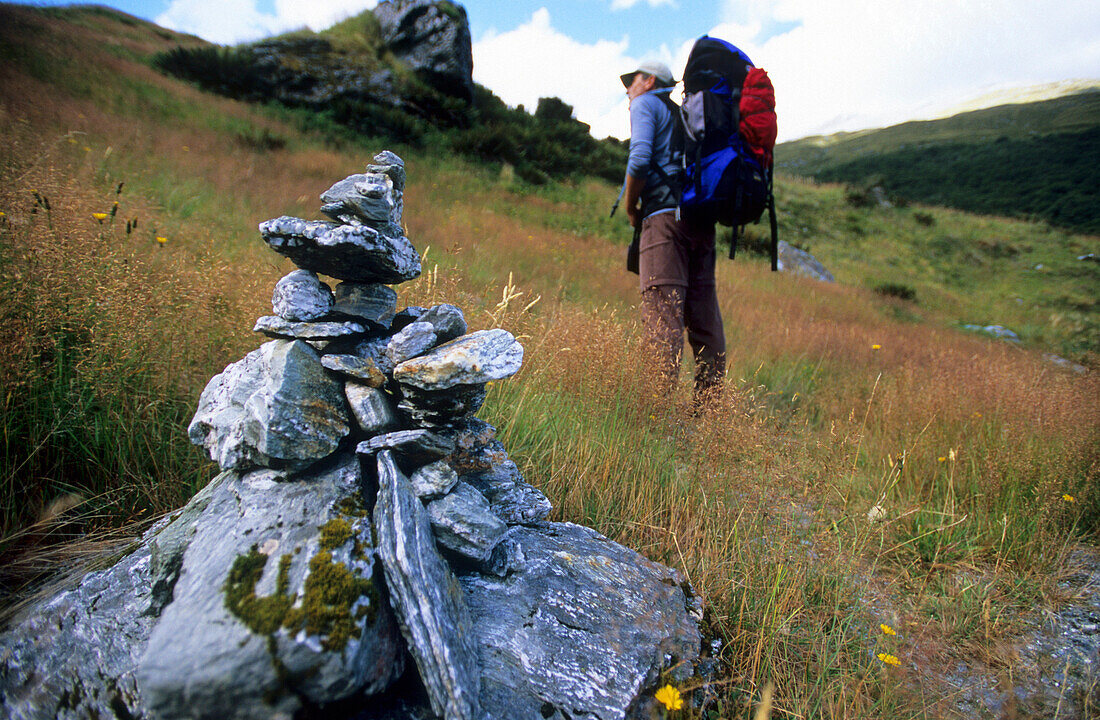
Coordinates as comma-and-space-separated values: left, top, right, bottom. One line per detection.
0, 4, 1100, 720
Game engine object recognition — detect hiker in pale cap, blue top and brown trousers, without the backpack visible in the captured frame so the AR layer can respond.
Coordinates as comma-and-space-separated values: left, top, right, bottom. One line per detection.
620, 62, 726, 406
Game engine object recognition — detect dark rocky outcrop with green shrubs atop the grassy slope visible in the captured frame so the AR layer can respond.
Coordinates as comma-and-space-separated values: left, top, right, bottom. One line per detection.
153, 0, 626, 184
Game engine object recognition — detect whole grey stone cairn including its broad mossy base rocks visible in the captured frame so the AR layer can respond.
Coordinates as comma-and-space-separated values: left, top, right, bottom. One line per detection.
0, 152, 701, 720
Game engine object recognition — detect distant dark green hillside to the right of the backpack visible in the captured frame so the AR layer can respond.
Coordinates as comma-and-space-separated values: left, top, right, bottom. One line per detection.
776, 87, 1100, 233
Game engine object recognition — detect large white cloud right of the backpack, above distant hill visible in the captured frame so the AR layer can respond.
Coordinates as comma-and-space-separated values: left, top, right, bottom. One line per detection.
717, 0, 1100, 140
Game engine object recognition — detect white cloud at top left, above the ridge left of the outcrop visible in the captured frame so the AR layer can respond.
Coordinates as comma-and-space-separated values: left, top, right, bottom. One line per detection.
155, 0, 377, 45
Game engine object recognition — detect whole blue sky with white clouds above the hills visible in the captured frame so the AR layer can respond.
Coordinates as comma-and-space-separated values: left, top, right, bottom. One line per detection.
17, 0, 1100, 141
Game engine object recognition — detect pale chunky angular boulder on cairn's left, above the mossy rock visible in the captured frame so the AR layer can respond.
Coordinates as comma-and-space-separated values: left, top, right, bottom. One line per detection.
187, 340, 350, 469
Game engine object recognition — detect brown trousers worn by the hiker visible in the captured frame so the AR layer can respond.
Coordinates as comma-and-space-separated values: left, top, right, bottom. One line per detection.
638, 212, 726, 401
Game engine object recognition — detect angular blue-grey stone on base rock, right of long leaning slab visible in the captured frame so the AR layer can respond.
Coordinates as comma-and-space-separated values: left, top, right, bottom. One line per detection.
428, 483, 508, 563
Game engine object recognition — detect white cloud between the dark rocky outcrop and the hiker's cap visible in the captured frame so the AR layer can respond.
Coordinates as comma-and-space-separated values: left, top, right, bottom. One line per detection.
473, 8, 642, 137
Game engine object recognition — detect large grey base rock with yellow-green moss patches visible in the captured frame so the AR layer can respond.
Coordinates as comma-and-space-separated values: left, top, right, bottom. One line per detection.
136, 454, 404, 719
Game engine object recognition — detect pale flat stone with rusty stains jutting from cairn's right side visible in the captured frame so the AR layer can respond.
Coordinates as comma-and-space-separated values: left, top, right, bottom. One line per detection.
394, 329, 524, 390
